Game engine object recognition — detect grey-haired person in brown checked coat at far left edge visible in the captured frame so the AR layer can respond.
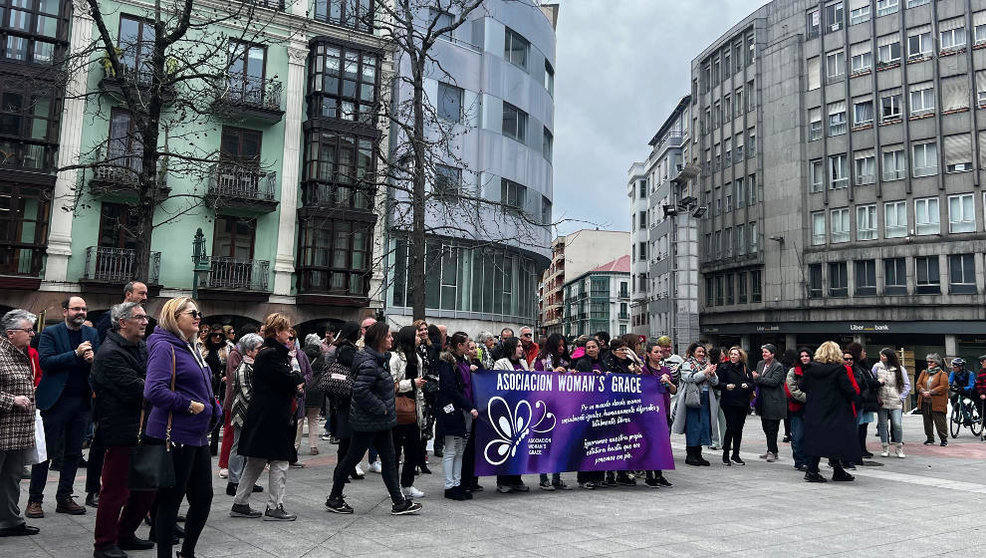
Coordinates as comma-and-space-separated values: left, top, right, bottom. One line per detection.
0, 310, 38, 537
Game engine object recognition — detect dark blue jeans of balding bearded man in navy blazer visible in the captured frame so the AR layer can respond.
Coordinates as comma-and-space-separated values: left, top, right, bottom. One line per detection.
28, 396, 92, 502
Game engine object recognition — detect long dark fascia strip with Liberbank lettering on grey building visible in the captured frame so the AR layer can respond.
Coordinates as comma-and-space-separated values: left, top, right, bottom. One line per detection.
702, 320, 986, 335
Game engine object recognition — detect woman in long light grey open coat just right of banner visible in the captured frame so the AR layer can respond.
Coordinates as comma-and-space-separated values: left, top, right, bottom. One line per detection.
672, 343, 719, 467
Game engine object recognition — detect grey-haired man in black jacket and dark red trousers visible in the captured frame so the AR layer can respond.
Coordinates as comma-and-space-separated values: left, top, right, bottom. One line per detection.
87, 302, 154, 558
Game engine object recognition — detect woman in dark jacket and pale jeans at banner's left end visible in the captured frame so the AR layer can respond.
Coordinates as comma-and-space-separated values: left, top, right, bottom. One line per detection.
435, 331, 479, 501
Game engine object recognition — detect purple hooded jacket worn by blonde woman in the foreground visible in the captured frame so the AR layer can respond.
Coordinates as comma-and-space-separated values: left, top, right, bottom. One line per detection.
144, 326, 223, 446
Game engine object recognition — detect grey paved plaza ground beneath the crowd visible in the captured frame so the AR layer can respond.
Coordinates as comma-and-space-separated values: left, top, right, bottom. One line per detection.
7, 416, 986, 558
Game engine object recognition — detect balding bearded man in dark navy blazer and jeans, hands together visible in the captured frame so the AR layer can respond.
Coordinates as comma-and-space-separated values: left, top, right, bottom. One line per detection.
25, 296, 99, 518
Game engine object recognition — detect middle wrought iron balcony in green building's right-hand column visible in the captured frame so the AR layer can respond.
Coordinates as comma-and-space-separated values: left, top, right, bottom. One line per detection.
206, 161, 278, 213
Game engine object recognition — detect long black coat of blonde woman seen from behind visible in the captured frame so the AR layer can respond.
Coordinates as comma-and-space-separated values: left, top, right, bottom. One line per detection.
801, 362, 861, 463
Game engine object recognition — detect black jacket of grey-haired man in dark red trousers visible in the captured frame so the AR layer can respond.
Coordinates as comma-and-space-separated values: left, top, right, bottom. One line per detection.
90, 330, 147, 446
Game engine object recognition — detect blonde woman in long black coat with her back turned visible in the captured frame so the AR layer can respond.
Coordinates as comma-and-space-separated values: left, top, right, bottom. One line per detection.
800, 341, 860, 482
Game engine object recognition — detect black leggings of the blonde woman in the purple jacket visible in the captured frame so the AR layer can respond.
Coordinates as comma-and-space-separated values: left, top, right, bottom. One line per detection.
154, 441, 212, 558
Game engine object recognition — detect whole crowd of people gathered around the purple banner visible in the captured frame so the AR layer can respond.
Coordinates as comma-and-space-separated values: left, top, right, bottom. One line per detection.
0, 290, 986, 558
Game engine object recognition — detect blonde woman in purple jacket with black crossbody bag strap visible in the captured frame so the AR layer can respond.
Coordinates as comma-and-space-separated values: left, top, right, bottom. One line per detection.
144, 296, 223, 558
